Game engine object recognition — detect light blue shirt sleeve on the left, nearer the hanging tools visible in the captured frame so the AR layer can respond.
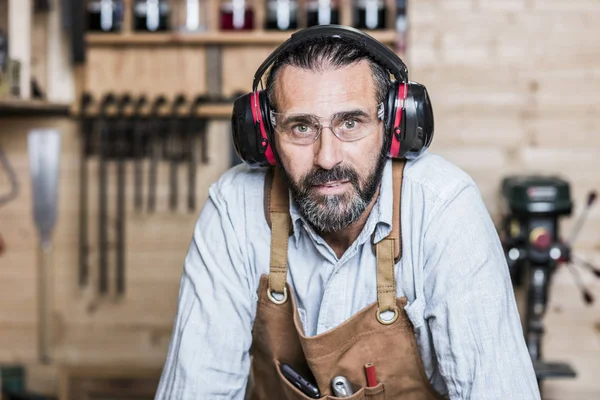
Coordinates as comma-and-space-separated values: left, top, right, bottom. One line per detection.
155, 182, 255, 400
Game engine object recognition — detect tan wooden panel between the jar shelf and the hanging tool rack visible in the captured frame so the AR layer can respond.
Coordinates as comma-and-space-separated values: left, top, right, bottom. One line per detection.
85, 45, 276, 99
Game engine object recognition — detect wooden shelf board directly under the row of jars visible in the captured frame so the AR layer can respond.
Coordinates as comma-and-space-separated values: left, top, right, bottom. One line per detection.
86, 30, 396, 47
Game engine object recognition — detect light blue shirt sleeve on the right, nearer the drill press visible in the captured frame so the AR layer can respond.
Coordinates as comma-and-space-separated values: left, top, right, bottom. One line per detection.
424, 181, 540, 400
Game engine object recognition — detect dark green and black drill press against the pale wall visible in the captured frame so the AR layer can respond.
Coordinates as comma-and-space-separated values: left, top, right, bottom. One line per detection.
500, 175, 600, 384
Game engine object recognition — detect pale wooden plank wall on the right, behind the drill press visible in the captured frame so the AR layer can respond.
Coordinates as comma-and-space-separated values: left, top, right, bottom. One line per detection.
407, 0, 600, 400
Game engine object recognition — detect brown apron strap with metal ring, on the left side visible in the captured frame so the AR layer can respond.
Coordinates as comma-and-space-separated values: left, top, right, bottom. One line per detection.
265, 168, 291, 304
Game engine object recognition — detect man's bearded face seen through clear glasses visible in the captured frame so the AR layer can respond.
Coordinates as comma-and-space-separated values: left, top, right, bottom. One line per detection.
275, 61, 387, 232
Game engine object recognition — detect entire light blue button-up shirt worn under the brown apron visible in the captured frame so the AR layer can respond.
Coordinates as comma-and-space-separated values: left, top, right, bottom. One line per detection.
156, 153, 540, 400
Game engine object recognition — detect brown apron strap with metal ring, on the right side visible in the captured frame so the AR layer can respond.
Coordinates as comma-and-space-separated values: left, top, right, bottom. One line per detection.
375, 160, 405, 324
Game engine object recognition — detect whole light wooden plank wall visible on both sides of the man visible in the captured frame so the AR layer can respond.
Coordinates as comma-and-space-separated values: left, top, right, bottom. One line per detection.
0, 0, 600, 400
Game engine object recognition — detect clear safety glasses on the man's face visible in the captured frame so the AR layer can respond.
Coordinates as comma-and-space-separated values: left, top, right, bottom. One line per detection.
270, 103, 383, 145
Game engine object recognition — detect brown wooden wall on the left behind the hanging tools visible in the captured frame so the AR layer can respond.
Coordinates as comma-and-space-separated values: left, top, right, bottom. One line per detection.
0, 117, 231, 393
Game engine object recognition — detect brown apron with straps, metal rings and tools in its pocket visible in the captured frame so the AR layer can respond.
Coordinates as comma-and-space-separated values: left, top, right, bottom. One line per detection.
250, 161, 442, 400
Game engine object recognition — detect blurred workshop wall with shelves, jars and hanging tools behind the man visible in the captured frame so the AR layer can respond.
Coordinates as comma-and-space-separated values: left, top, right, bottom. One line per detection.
0, 0, 600, 400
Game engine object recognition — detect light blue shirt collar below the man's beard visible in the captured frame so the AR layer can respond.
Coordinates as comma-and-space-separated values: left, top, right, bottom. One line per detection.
289, 160, 394, 246
